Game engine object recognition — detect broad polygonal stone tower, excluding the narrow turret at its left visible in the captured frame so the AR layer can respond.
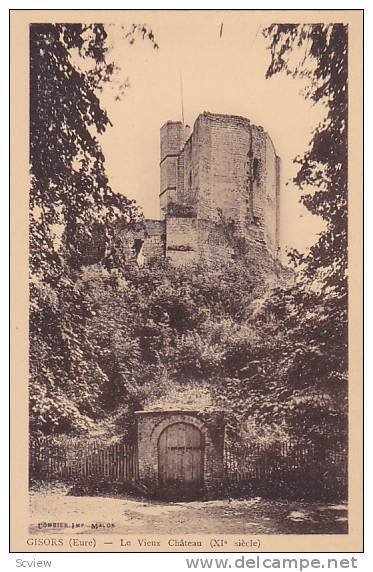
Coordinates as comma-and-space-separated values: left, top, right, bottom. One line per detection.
169, 113, 279, 254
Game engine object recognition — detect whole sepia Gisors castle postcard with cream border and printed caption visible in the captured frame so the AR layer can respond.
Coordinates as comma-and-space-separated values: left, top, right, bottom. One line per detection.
10, 10, 363, 553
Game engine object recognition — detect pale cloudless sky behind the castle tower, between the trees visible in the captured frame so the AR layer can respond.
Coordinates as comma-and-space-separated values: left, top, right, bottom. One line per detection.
97, 11, 323, 260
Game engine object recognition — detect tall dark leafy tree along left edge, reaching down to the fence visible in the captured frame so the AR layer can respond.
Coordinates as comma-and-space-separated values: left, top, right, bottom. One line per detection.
30, 24, 156, 432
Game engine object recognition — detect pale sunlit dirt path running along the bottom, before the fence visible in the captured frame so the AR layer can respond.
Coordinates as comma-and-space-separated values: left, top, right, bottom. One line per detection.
30, 487, 347, 534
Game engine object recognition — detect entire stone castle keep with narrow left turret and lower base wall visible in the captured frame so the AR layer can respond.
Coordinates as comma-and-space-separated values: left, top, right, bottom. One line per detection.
129, 112, 280, 264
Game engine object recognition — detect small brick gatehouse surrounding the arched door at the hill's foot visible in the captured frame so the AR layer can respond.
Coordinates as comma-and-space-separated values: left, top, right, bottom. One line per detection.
136, 410, 224, 497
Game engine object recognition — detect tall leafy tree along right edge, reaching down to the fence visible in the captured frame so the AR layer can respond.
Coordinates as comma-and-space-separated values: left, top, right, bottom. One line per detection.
251, 24, 348, 438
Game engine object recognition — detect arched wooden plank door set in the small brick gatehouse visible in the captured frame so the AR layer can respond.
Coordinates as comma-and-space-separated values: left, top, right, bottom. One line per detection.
158, 423, 203, 498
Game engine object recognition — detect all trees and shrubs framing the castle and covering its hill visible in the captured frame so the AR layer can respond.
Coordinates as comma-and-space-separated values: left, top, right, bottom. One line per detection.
30, 24, 348, 498
